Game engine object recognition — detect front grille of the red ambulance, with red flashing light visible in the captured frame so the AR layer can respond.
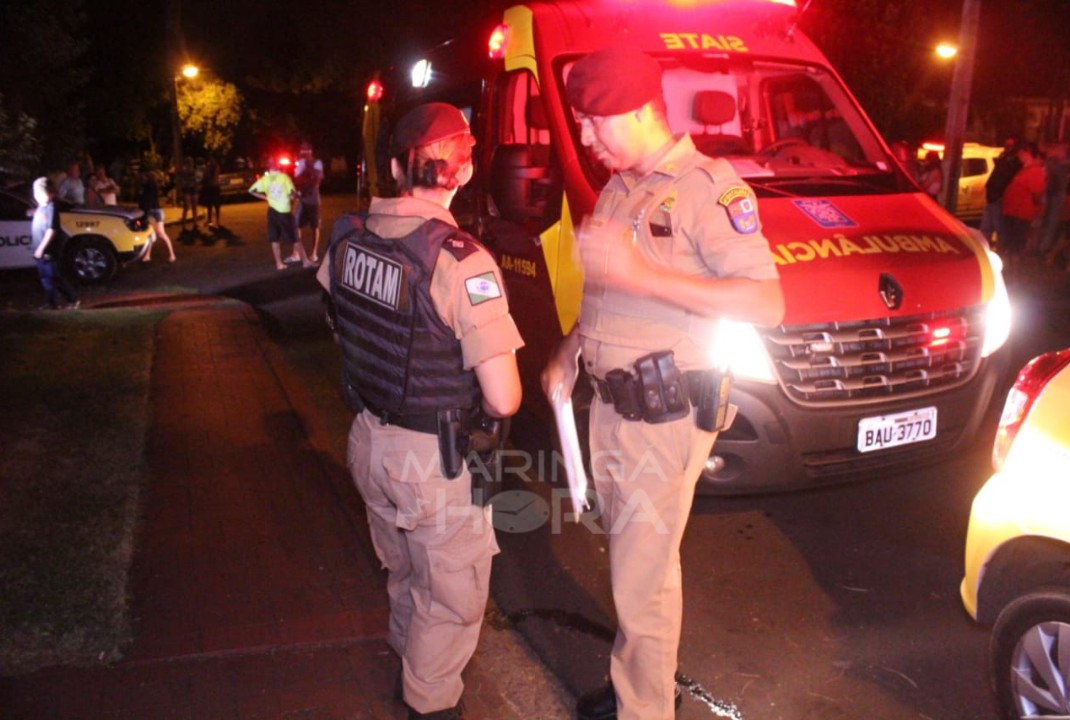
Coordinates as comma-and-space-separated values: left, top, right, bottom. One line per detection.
765, 307, 984, 405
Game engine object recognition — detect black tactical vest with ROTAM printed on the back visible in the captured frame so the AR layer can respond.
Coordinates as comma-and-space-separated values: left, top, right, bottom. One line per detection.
328, 213, 479, 415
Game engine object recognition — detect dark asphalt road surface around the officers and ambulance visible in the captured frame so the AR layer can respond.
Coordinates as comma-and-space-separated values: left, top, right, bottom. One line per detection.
8, 196, 1070, 720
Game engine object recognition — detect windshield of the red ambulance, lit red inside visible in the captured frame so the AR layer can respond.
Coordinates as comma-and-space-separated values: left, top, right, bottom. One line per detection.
565, 56, 910, 196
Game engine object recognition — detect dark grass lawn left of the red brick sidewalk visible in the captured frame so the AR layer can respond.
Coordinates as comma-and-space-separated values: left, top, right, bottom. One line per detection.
0, 309, 164, 675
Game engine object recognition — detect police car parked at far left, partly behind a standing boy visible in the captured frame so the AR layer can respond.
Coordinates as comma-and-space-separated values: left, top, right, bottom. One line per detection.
0, 186, 156, 285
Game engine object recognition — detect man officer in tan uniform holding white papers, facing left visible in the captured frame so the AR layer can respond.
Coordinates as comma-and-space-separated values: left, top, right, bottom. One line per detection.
542, 48, 783, 720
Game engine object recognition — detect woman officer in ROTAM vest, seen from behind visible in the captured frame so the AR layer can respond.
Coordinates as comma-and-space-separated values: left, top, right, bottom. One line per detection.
317, 103, 523, 720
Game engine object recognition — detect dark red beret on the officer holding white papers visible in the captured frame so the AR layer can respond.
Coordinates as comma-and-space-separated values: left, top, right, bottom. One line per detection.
565, 47, 661, 117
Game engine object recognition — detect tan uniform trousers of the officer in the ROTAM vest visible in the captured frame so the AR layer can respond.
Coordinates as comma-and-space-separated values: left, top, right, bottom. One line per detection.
348, 411, 498, 713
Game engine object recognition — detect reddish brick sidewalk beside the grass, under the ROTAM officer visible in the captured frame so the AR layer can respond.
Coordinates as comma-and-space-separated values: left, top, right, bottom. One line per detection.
0, 298, 571, 720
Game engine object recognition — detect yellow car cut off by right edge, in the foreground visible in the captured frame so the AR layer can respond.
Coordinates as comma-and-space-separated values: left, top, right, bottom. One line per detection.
960, 349, 1070, 719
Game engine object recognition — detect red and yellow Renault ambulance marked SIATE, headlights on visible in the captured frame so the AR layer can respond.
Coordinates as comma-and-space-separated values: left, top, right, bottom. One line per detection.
364, 0, 1010, 493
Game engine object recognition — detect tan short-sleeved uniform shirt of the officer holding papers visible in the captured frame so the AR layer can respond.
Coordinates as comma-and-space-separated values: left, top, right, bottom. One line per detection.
579, 135, 778, 378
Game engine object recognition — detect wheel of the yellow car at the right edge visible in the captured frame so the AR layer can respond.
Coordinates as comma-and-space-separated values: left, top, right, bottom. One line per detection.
989, 587, 1070, 720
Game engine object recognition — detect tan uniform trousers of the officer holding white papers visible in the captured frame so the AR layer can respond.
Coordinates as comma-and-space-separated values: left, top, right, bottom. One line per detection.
591, 397, 717, 720
